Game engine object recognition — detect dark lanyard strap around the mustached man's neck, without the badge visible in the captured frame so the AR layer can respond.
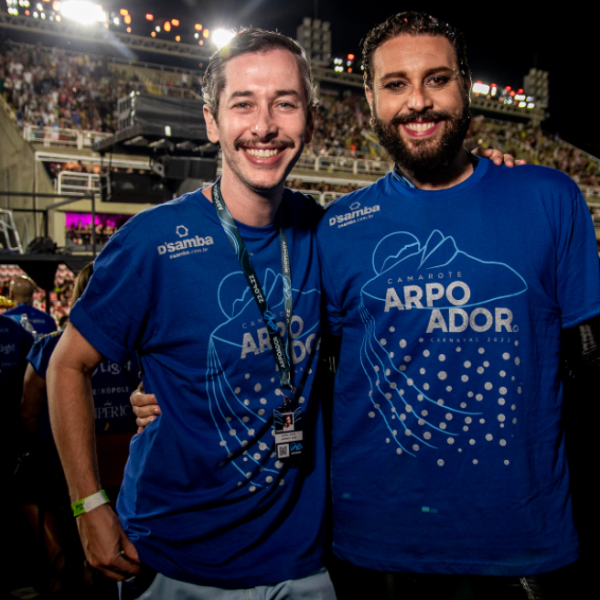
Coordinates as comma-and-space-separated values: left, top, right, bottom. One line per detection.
212, 177, 294, 404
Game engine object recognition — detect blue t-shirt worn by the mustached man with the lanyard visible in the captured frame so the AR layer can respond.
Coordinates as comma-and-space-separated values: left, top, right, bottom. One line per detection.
70, 191, 326, 588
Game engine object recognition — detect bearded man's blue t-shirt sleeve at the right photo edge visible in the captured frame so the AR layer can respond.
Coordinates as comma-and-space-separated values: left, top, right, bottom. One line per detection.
557, 192, 600, 329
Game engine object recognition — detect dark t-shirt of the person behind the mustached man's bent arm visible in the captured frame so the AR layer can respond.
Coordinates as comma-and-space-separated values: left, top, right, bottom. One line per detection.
27, 332, 139, 440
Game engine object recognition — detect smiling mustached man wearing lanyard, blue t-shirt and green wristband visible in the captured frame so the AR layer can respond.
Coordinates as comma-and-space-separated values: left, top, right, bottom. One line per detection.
48, 30, 334, 600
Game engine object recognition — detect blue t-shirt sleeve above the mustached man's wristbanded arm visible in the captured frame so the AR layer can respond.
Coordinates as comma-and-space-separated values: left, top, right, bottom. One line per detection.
69, 235, 152, 364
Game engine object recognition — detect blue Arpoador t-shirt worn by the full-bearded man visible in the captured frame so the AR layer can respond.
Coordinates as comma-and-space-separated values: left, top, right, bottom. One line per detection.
317, 160, 600, 575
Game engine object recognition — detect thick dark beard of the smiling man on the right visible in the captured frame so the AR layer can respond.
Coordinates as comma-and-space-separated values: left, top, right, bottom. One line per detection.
372, 102, 471, 181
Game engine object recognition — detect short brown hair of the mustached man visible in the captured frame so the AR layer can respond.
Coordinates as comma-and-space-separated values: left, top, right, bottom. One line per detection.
202, 28, 318, 123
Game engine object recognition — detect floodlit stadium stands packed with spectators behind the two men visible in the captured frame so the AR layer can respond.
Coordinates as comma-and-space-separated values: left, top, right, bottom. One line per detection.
0, 0, 600, 324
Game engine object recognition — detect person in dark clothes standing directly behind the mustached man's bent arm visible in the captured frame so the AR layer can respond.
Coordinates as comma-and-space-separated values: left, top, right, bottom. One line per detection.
15, 263, 138, 598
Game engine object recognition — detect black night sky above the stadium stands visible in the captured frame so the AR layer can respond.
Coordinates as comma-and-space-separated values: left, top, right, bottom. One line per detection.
103, 0, 600, 157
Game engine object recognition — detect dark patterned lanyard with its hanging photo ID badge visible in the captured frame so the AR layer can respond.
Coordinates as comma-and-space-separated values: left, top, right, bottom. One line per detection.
212, 178, 303, 459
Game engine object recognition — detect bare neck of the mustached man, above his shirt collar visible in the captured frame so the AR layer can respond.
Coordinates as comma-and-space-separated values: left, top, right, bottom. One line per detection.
202, 163, 284, 227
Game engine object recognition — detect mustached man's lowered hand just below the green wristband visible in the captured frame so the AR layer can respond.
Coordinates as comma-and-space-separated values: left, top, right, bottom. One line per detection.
77, 504, 140, 581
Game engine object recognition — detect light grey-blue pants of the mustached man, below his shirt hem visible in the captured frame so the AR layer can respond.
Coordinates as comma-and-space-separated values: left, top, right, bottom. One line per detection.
119, 568, 335, 600
